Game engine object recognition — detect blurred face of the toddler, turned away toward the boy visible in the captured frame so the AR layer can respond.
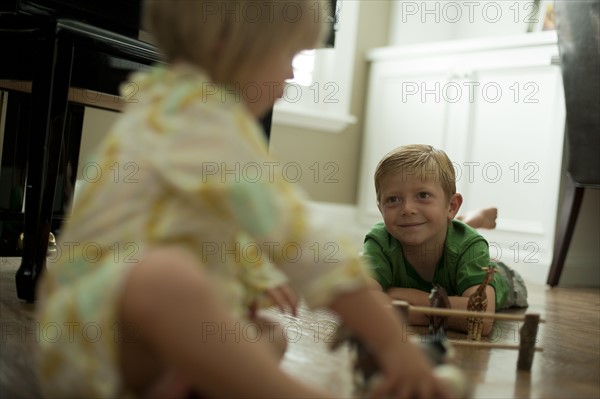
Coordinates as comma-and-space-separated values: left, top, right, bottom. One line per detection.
241, 48, 301, 117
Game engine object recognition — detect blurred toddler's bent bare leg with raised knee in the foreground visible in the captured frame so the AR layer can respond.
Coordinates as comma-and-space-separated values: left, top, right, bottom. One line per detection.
120, 247, 325, 398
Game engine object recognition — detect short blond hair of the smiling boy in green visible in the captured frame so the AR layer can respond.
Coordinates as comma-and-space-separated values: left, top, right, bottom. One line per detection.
375, 144, 456, 204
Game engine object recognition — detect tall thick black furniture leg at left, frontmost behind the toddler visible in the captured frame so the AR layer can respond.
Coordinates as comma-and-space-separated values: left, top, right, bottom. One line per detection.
16, 34, 73, 302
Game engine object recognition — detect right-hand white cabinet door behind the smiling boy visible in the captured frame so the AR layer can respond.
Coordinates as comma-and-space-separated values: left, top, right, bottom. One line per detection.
458, 65, 565, 264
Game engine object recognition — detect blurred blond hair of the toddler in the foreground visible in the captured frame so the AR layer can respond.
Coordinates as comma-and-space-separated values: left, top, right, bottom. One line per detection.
143, 0, 328, 83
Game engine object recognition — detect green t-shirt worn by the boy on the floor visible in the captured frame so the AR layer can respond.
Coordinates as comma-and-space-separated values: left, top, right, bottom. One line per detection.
363, 220, 508, 309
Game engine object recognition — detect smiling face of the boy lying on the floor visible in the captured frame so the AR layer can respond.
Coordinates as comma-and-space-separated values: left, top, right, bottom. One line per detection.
378, 172, 462, 248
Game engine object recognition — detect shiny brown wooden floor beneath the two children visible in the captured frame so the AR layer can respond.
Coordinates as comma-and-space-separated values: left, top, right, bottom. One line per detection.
0, 258, 600, 399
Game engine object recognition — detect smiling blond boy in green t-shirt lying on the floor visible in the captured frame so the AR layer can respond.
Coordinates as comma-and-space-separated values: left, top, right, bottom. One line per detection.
363, 144, 526, 335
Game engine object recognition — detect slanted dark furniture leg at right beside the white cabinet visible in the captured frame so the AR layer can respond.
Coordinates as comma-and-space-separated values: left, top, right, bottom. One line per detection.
546, 175, 585, 287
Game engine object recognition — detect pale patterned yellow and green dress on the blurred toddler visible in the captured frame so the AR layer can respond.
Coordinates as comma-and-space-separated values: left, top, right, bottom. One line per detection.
38, 65, 368, 398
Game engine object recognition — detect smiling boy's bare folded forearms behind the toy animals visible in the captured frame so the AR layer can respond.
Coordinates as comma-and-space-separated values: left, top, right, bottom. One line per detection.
387, 286, 496, 336
